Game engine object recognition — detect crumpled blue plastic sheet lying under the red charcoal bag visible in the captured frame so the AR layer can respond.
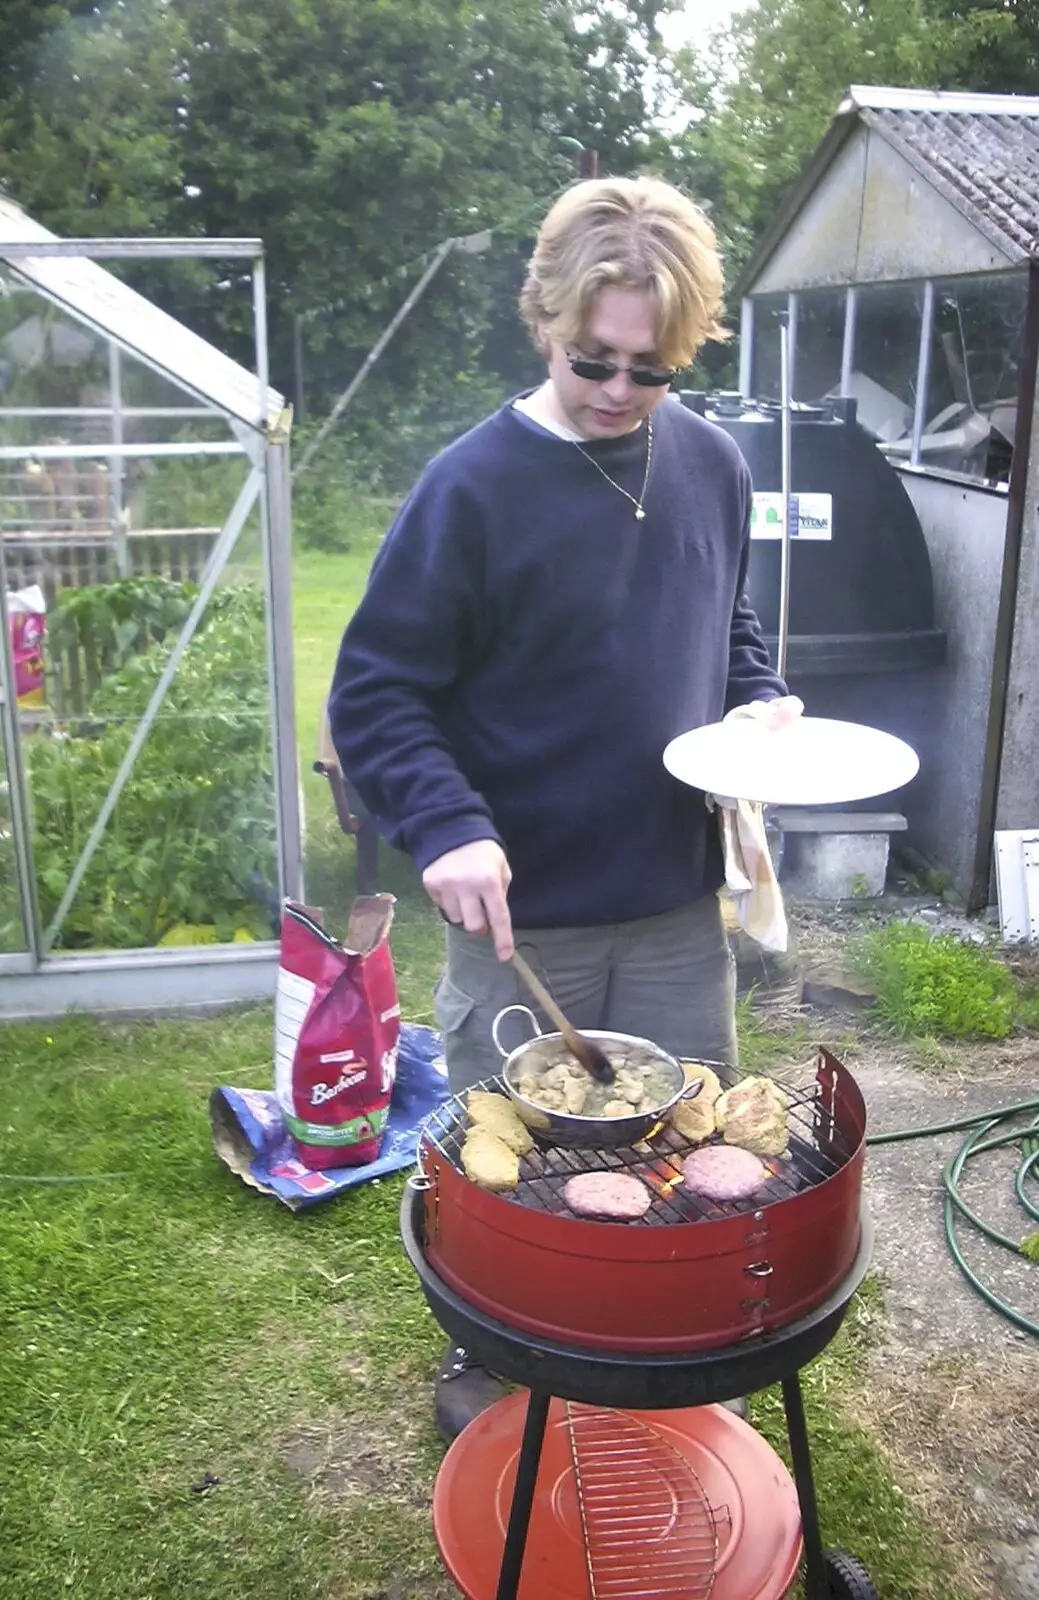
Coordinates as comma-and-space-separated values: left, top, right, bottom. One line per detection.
210, 1022, 451, 1211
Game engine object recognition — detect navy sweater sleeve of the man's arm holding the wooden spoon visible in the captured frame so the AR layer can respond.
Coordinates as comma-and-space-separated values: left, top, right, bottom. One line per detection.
328, 469, 498, 872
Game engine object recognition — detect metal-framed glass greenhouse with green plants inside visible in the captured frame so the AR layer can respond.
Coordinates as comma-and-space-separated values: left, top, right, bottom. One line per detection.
0, 200, 301, 1016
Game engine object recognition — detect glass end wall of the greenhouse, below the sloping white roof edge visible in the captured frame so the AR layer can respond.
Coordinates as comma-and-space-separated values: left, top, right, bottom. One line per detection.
0, 291, 277, 952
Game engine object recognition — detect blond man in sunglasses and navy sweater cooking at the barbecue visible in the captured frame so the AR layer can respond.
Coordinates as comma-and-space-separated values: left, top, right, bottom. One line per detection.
330, 178, 800, 1437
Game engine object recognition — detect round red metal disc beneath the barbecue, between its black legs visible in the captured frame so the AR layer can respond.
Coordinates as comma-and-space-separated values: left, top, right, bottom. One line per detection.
434, 1395, 800, 1600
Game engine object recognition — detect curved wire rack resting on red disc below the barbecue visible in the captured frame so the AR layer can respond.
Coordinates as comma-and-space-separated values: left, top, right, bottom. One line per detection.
567, 1402, 719, 1600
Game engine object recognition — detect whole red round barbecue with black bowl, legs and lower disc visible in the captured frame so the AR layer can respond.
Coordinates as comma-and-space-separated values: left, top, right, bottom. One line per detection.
402, 1051, 876, 1600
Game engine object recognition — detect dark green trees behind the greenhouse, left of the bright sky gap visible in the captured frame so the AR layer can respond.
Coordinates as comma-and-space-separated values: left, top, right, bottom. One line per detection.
0, 0, 660, 428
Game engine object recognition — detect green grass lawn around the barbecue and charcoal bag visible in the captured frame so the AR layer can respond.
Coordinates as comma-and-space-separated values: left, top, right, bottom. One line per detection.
0, 508, 957, 1600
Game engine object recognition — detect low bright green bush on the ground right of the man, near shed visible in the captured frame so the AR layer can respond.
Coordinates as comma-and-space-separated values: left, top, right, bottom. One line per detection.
848, 923, 1017, 1038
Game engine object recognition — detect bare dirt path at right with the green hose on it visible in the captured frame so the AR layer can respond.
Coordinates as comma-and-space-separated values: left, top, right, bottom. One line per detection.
781, 907, 1039, 1600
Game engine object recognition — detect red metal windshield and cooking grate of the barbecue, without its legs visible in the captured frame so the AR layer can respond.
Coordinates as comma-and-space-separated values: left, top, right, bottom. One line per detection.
419, 1051, 866, 1354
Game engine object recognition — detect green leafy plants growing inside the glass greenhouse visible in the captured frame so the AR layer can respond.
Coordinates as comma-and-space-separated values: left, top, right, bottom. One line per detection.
27, 587, 277, 949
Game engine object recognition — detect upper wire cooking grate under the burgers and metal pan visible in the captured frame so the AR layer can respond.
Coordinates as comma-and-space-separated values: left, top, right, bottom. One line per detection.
419, 1066, 853, 1227
